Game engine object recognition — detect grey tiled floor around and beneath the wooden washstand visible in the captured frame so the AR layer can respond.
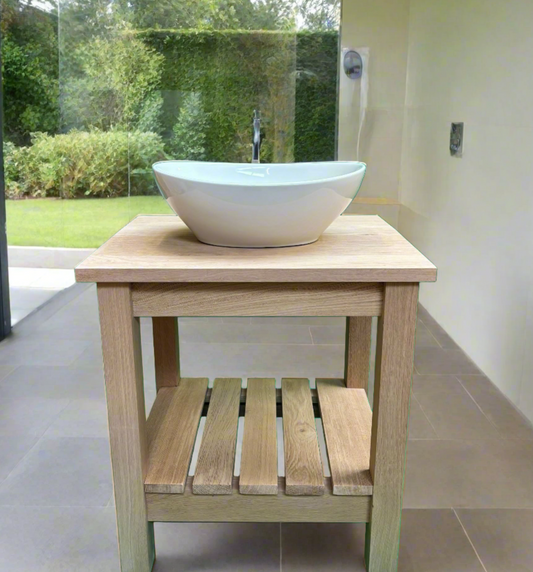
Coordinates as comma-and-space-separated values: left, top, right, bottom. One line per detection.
0, 286, 533, 572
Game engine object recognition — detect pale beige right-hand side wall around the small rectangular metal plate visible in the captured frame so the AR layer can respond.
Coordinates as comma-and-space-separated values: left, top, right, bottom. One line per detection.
399, 0, 533, 421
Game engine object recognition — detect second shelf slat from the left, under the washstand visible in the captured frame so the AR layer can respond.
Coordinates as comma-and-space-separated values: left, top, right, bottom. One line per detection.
192, 378, 241, 495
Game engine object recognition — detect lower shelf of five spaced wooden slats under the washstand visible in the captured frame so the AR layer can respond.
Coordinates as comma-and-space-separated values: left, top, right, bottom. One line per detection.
145, 378, 372, 500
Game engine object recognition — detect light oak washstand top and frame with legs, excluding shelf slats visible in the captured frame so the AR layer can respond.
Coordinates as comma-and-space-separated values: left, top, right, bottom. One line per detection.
80, 217, 436, 572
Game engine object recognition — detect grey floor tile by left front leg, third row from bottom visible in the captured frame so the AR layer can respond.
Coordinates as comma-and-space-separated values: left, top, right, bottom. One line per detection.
45, 398, 108, 438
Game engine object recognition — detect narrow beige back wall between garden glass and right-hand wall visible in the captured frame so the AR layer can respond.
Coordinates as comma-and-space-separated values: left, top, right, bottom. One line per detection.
338, 0, 409, 224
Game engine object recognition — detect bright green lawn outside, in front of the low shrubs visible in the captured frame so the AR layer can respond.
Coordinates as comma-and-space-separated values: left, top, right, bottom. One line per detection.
6, 196, 172, 248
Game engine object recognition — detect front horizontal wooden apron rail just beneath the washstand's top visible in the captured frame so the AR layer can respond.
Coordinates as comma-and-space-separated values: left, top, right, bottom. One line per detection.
132, 283, 383, 316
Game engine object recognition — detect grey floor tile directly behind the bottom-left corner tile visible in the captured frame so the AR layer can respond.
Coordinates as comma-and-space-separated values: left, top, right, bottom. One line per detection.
0, 437, 112, 507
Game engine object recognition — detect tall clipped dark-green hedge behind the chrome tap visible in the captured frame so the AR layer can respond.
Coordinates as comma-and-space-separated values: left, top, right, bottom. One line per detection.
137, 30, 338, 162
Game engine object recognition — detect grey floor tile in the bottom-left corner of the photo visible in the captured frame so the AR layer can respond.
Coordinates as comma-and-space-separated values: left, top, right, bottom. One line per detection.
0, 507, 119, 572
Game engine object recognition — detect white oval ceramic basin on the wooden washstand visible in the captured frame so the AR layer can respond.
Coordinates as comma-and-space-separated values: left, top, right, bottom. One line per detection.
153, 161, 366, 248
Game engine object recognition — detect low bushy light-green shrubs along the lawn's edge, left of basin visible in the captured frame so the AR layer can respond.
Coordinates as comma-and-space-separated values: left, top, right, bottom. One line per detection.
4, 130, 165, 198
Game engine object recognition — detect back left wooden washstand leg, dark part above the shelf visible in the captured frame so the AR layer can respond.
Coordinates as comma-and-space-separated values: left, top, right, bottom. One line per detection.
152, 318, 180, 391
